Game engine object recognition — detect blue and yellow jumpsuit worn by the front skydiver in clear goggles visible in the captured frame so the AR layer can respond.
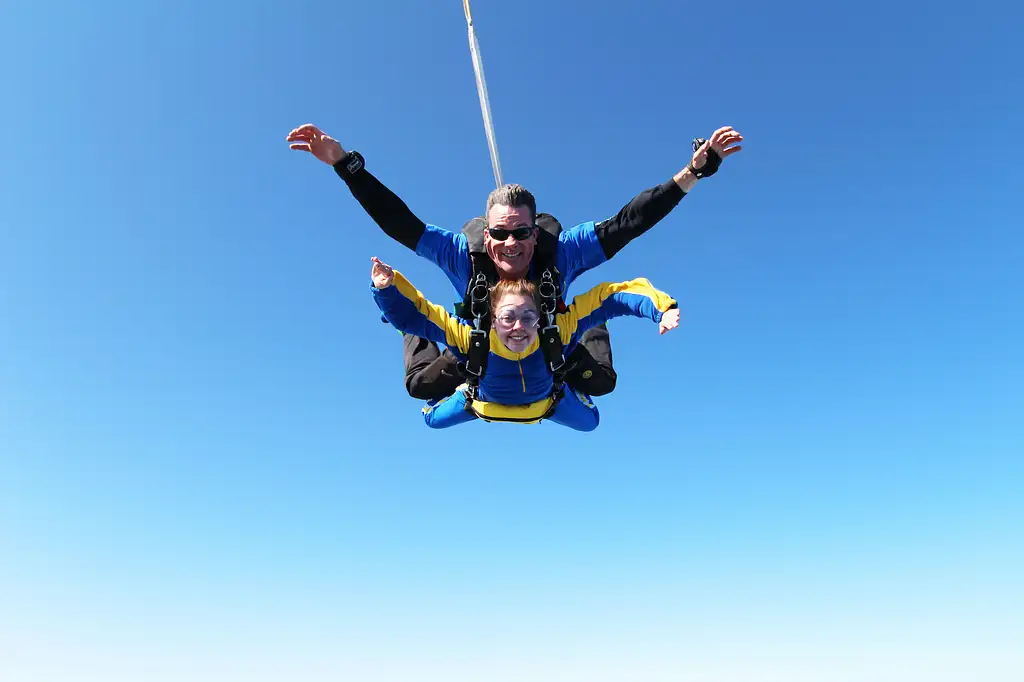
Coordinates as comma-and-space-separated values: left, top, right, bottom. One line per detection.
370, 270, 676, 431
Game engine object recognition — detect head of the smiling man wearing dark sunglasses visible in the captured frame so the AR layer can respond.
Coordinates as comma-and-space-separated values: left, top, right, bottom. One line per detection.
483, 184, 537, 280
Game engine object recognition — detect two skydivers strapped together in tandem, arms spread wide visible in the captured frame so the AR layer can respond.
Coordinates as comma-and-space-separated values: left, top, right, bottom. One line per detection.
288, 124, 742, 431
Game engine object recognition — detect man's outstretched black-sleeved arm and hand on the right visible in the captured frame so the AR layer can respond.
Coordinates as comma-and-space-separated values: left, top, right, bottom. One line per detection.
594, 126, 743, 258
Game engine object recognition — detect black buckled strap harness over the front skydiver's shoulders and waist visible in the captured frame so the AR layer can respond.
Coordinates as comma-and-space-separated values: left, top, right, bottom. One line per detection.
456, 213, 572, 423
